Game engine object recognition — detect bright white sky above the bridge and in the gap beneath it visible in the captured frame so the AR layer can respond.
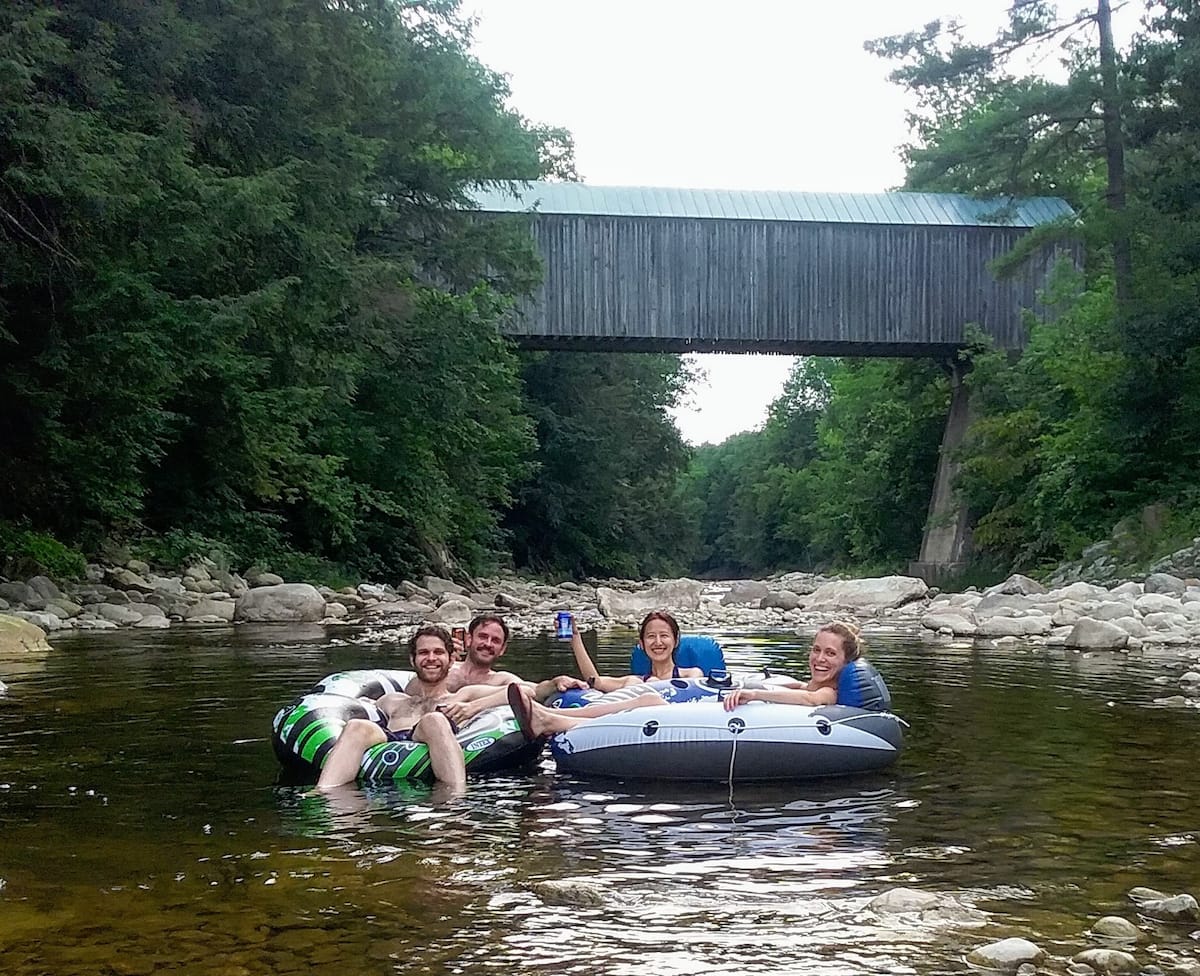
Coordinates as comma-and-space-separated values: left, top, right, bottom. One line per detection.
463, 0, 1099, 443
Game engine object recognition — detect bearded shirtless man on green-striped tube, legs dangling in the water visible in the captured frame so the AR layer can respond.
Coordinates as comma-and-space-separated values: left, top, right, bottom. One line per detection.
317, 625, 505, 792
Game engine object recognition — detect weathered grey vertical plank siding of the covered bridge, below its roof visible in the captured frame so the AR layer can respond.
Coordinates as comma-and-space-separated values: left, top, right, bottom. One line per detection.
511, 215, 1049, 347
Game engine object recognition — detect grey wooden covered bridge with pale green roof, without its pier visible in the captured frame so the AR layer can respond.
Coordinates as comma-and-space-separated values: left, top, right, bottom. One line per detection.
474, 182, 1072, 357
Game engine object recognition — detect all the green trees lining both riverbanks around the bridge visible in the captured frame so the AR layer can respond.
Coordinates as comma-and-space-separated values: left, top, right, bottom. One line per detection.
0, 0, 1200, 580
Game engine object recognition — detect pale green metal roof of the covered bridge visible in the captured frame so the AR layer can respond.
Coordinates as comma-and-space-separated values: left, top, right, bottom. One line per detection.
470, 180, 1073, 227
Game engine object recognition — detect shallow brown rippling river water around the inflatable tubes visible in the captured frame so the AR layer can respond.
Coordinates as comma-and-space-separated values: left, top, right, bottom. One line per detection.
0, 627, 1200, 976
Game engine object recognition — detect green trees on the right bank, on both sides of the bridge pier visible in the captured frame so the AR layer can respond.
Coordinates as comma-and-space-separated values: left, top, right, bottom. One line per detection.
688, 0, 1200, 571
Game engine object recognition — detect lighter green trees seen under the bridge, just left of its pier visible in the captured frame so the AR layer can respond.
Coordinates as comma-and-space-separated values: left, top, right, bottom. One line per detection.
685, 359, 949, 573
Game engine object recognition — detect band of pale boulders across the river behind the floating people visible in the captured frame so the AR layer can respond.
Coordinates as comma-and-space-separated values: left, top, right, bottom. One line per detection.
0, 559, 1200, 677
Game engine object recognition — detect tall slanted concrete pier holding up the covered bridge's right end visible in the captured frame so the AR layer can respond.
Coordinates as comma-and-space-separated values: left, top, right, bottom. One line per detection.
908, 363, 971, 583
